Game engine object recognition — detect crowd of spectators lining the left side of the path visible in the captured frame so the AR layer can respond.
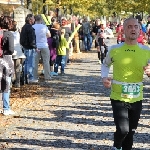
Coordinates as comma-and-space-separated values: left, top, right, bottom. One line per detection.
0, 14, 116, 115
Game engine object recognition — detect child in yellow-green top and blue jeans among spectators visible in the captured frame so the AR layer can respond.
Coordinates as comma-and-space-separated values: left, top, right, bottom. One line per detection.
54, 29, 69, 75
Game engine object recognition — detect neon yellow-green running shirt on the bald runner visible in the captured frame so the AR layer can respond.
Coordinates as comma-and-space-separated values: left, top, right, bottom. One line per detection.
103, 43, 150, 103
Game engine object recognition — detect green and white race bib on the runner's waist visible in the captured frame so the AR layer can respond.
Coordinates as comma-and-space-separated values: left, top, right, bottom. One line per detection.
121, 84, 140, 98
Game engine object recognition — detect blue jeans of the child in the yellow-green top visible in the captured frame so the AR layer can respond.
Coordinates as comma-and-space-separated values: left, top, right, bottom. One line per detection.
54, 55, 66, 73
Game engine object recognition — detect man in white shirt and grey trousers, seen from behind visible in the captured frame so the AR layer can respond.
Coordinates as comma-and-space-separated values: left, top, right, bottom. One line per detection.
32, 15, 50, 82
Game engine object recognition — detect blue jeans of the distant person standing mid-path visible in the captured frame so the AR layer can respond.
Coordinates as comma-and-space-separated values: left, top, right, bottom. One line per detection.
83, 33, 92, 51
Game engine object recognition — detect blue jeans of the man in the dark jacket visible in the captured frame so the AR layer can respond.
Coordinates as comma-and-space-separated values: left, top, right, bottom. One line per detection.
23, 48, 35, 80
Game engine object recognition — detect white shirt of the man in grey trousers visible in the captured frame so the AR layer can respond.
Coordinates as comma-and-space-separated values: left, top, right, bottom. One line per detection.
32, 24, 49, 48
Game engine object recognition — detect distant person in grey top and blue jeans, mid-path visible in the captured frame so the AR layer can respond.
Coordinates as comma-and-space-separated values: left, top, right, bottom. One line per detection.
82, 17, 92, 51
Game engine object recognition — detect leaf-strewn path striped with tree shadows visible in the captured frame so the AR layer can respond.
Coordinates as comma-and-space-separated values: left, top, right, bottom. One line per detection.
0, 40, 150, 150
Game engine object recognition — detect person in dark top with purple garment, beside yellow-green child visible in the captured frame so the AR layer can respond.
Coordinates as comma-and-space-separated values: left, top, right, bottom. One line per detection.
47, 23, 60, 76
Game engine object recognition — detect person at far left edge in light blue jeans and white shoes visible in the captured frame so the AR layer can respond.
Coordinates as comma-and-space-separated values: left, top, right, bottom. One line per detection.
0, 19, 15, 115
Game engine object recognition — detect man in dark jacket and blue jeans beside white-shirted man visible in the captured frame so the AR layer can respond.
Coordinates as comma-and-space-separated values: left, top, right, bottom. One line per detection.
20, 14, 38, 84
